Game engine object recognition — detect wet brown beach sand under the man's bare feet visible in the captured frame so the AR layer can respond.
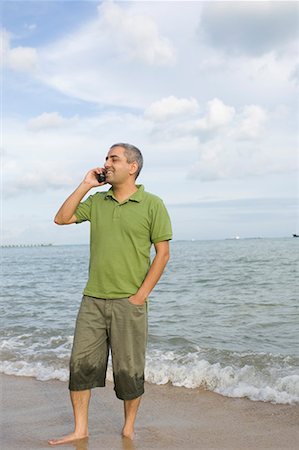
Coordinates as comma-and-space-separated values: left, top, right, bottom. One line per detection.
0, 375, 299, 450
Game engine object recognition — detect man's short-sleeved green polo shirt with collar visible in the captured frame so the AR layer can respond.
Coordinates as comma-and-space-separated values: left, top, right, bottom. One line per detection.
75, 185, 172, 298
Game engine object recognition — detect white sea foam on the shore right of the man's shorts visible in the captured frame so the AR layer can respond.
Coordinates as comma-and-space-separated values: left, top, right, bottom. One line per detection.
146, 351, 299, 404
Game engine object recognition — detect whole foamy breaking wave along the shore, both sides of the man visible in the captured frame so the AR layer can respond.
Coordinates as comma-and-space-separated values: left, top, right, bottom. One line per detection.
0, 338, 299, 404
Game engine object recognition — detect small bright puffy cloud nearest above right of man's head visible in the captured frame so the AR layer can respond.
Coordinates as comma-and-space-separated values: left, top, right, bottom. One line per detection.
144, 95, 199, 122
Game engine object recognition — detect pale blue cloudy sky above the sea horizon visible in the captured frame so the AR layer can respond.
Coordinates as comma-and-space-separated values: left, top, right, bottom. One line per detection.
1, 0, 299, 245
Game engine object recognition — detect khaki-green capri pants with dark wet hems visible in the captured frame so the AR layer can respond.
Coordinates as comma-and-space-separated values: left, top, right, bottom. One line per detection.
69, 295, 148, 400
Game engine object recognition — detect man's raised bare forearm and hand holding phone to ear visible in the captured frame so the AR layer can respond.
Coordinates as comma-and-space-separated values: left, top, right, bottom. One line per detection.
54, 167, 105, 225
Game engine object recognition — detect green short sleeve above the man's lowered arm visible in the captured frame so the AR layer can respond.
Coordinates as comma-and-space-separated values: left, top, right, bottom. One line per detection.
151, 199, 172, 244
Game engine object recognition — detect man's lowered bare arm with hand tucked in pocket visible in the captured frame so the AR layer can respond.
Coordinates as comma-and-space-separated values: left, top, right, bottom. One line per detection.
130, 241, 169, 305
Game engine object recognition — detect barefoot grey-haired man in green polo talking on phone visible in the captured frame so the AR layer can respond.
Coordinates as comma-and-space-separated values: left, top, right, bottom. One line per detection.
49, 143, 172, 445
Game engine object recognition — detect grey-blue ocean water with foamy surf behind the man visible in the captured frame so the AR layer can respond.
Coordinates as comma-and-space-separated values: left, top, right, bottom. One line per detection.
0, 238, 299, 404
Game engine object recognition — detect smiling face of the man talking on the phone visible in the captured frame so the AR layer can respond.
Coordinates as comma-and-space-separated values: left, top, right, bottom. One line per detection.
104, 147, 132, 185
